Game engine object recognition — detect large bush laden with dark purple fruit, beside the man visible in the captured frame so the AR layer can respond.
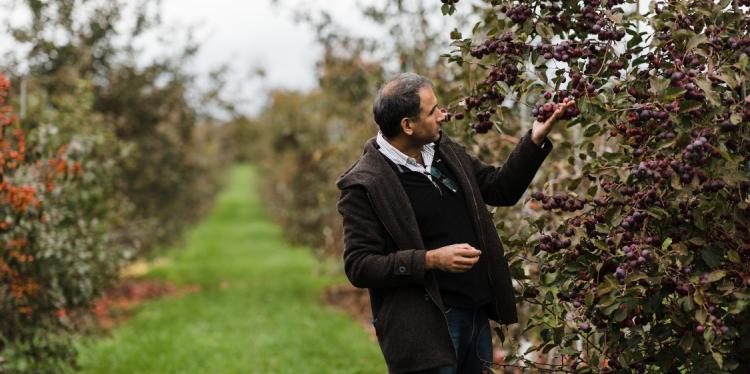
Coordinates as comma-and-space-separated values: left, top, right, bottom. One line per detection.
442, 0, 750, 373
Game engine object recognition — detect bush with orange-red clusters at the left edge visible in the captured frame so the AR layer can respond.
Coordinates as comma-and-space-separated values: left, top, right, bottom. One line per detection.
0, 74, 125, 373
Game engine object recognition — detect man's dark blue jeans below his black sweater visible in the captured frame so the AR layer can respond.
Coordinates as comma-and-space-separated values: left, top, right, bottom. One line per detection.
417, 307, 492, 374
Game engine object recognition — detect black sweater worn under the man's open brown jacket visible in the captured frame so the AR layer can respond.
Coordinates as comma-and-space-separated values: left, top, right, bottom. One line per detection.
383, 152, 492, 307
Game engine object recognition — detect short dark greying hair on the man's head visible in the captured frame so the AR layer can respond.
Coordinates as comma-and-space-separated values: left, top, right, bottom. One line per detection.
372, 73, 432, 138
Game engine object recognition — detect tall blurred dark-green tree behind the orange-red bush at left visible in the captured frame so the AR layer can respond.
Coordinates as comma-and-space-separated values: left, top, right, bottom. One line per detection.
3, 0, 227, 255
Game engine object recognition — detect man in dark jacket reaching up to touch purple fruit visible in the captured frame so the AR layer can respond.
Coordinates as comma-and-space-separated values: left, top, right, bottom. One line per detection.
337, 74, 572, 373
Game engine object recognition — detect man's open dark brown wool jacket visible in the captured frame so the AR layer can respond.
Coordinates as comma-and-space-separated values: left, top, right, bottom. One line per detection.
336, 131, 552, 373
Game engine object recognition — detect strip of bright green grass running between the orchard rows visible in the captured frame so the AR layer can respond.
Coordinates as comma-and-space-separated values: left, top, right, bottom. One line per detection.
78, 166, 386, 374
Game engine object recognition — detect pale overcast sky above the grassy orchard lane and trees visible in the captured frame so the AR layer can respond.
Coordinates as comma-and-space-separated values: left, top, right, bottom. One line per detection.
156, 0, 379, 112
